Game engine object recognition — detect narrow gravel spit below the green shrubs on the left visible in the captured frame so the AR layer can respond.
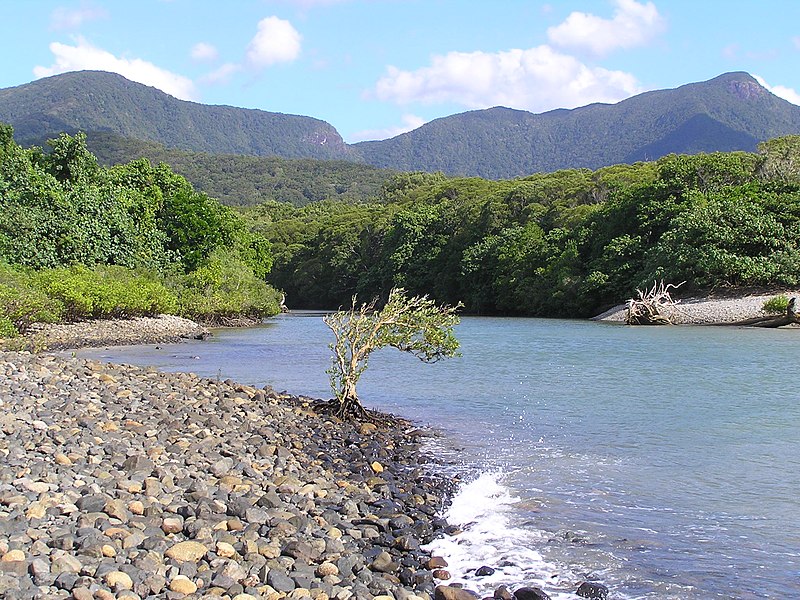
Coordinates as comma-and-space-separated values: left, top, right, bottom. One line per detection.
0, 315, 209, 350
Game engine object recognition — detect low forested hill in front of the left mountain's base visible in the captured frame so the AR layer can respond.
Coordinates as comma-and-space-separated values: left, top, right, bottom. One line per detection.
87, 132, 392, 206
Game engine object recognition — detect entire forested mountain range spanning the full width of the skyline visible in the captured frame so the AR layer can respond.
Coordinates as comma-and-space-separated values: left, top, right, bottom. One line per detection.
0, 71, 800, 179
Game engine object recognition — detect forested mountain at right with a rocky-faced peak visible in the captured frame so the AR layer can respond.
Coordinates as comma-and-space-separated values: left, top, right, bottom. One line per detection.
356, 73, 800, 179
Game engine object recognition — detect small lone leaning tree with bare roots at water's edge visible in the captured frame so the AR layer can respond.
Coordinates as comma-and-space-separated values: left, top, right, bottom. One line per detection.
323, 288, 461, 419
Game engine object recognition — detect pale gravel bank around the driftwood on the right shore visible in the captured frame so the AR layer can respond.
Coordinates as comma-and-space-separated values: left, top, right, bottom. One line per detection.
593, 292, 800, 325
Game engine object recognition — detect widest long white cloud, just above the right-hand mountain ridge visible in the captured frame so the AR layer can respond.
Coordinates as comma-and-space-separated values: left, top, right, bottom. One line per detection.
373, 46, 642, 112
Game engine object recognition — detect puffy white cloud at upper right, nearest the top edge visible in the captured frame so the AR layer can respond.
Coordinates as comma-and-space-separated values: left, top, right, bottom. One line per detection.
547, 0, 665, 56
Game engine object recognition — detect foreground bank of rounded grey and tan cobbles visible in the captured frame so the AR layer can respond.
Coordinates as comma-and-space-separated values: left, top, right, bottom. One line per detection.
0, 352, 462, 600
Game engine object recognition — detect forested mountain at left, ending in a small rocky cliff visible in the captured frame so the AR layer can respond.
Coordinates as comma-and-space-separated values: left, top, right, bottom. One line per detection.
0, 71, 355, 159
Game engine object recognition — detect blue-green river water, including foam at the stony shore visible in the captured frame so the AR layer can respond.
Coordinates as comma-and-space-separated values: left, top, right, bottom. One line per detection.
81, 314, 800, 599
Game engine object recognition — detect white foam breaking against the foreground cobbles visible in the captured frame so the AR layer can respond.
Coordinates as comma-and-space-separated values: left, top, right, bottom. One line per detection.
425, 473, 577, 600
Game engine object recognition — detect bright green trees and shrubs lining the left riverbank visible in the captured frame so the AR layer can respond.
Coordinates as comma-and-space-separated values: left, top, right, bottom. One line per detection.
0, 124, 280, 337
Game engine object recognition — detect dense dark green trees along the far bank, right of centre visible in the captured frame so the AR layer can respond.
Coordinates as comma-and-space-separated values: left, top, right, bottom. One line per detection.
244, 138, 800, 316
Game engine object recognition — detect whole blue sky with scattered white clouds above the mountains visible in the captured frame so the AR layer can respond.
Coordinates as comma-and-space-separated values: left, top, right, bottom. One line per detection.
0, 0, 800, 142
